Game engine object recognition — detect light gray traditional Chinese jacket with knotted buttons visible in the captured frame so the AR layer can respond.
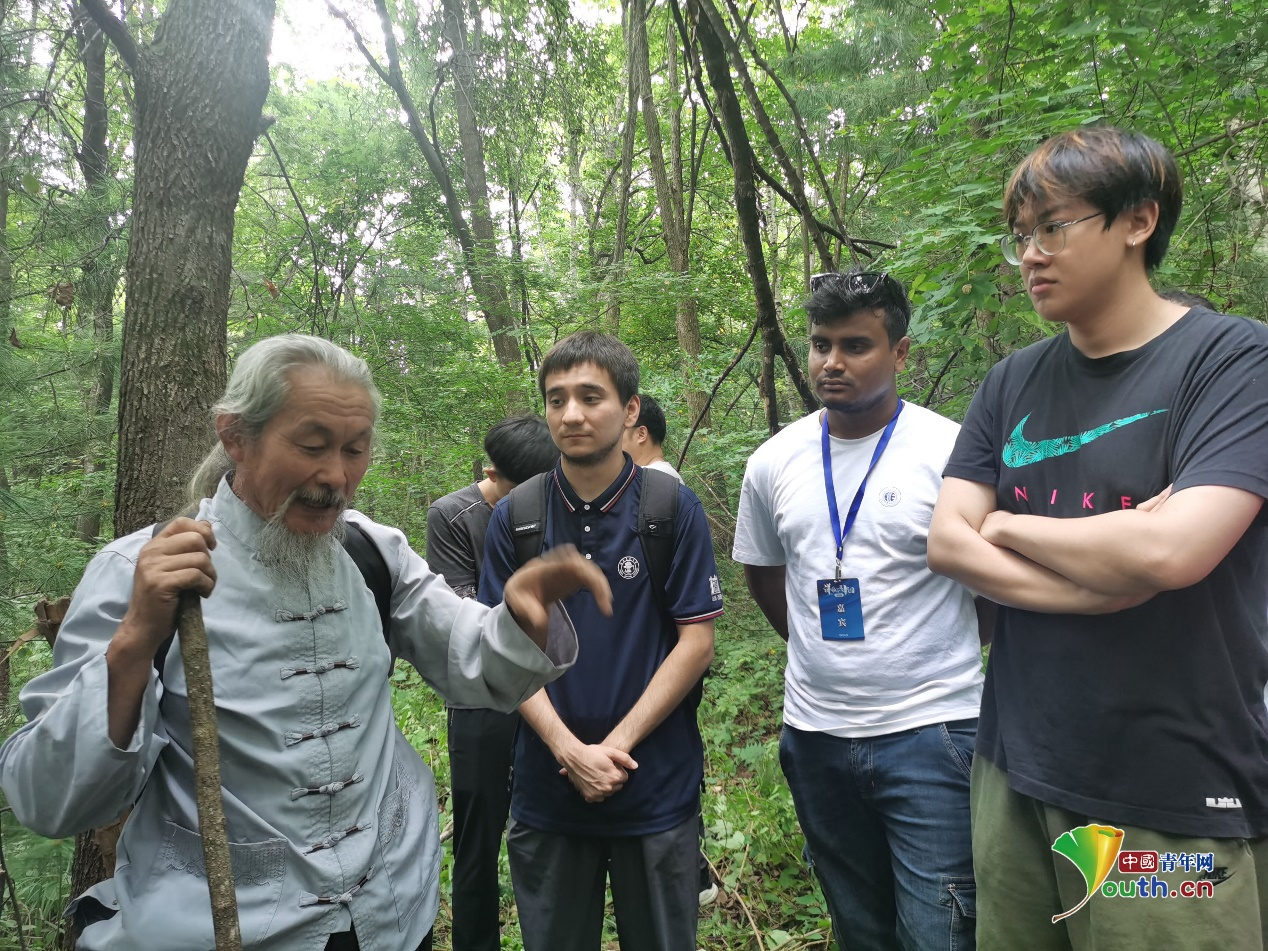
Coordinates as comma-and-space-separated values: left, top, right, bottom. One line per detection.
0, 482, 577, 951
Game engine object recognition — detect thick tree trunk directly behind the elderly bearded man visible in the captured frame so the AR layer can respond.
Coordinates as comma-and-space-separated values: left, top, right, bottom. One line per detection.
84, 0, 274, 536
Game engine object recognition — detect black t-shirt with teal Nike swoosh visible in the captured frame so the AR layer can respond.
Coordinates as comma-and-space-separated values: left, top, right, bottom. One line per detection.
945, 308, 1268, 838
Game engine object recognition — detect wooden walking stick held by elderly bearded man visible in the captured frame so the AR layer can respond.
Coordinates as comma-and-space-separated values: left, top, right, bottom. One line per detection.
176, 591, 242, 951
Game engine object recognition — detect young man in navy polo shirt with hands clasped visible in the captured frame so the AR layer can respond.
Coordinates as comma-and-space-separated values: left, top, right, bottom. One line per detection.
479, 331, 721, 951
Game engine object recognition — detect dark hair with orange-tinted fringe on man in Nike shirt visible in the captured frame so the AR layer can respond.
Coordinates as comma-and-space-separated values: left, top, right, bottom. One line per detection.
1004, 126, 1184, 270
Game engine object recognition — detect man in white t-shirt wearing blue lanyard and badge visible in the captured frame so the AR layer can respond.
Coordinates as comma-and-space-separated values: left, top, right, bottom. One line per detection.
733, 271, 983, 951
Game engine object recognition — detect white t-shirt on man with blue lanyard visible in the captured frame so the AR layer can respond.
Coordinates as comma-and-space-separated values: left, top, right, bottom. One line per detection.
732, 403, 983, 737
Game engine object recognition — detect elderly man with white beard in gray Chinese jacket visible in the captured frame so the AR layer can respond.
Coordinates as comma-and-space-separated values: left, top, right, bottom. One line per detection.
0, 335, 610, 951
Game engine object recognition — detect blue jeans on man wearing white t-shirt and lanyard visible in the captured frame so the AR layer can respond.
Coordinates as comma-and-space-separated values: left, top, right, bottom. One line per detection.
780, 720, 978, 951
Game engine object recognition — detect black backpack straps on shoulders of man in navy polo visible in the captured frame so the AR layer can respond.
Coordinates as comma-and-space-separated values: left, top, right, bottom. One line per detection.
507, 468, 678, 614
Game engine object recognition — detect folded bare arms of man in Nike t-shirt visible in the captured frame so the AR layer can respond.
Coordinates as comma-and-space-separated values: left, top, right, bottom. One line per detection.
929, 478, 1263, 614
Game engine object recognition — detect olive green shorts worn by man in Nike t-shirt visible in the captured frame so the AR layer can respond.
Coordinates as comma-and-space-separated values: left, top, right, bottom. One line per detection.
970, 756, 1268, 951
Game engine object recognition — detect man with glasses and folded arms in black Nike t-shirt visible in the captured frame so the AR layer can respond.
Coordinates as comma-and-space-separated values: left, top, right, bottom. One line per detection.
929, 126, 1268, 951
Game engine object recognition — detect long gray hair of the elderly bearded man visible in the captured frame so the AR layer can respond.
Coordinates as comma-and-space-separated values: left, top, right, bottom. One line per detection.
185, 333, 383, 508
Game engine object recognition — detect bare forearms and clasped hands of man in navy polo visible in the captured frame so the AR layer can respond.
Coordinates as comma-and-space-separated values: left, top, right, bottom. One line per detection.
520, 621, 714, 803
